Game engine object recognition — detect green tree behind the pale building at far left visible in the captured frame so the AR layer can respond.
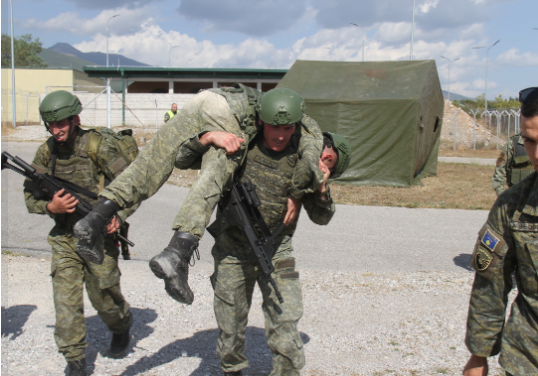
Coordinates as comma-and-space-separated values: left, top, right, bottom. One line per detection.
2, 34, 48, 68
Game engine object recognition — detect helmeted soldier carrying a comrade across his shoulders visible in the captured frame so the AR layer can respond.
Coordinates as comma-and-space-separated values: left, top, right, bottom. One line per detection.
189, 92, 351, 376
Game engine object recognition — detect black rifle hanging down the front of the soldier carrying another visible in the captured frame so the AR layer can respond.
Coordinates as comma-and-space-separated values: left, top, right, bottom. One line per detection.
207, 176, 284, 304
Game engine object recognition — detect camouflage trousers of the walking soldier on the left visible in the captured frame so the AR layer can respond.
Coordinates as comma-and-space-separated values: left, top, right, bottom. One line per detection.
48, 226, 132, 362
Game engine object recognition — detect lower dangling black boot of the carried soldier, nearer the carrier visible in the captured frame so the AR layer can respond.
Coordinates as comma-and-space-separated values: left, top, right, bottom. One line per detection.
149, 231, 200, 304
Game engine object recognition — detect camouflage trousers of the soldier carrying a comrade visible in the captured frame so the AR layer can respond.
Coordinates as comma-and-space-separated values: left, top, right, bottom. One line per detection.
211, 245, 305, 376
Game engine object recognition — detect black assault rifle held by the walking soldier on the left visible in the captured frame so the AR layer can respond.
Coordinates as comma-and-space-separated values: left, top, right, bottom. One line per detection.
2, 152, 134, 260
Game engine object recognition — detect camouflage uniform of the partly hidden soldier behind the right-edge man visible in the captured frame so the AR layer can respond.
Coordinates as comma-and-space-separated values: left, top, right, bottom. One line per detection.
492, 135, 534, 196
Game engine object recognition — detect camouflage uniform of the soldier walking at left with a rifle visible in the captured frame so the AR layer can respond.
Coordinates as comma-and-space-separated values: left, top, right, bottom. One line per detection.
24, 130, 137, 362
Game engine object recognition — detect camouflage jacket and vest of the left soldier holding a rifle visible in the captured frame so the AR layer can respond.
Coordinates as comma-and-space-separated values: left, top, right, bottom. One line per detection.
24, 130, 139, 226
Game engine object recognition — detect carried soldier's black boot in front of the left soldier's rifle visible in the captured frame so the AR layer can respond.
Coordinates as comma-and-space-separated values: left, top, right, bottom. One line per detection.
73, 197, 120, 265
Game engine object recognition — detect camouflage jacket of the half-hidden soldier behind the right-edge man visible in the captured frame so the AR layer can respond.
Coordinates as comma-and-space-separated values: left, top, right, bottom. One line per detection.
491, 135, 532, 196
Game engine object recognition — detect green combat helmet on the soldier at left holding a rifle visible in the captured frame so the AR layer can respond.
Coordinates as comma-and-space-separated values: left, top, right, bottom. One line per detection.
39, 90, 82, 125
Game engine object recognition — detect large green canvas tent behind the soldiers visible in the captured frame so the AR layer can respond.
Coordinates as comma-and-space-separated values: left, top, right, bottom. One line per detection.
277, 60, 444, 187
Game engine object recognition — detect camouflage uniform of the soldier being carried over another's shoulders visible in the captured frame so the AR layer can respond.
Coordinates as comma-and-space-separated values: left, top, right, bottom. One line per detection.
100, 88, 323, 239
